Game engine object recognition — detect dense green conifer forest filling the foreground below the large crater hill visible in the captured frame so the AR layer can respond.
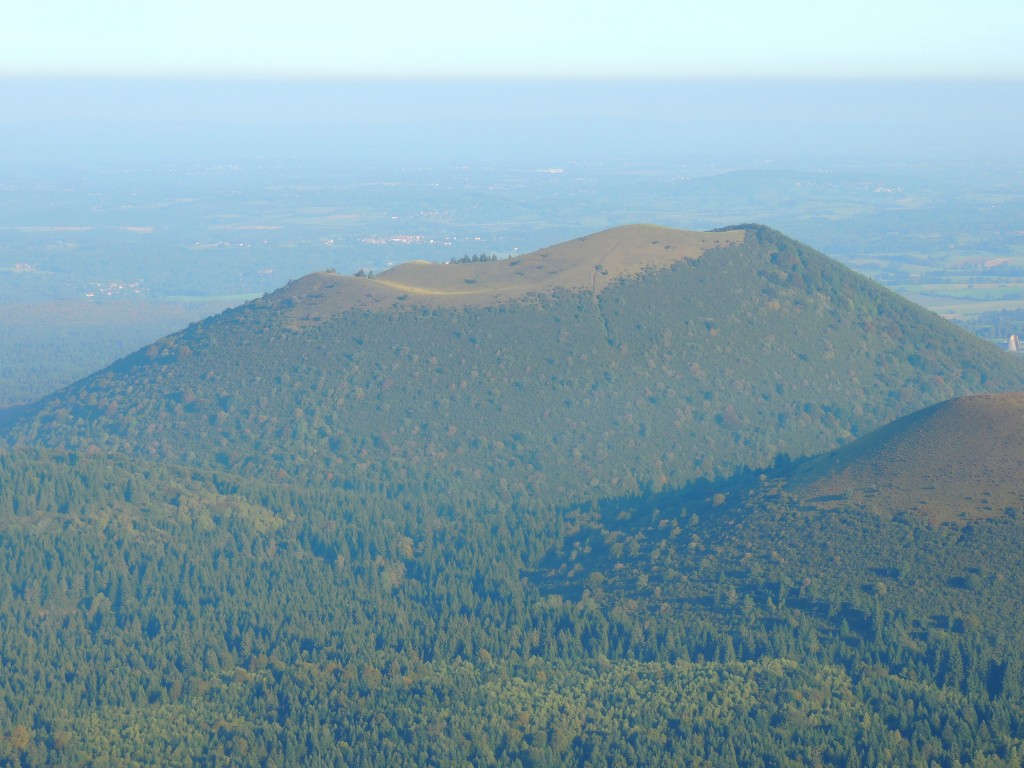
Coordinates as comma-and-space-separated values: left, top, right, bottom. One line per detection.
6, 415, 1024, 766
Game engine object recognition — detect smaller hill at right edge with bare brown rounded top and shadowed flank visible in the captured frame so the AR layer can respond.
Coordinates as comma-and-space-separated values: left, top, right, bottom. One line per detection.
538, 392, 1024, 618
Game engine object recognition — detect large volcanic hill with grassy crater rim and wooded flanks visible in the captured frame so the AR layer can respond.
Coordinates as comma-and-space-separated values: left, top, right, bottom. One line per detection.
0, 226, 1024, 501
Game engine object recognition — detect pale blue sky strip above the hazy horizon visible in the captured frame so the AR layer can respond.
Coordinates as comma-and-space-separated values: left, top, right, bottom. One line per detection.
0, 0, 1024, 79
